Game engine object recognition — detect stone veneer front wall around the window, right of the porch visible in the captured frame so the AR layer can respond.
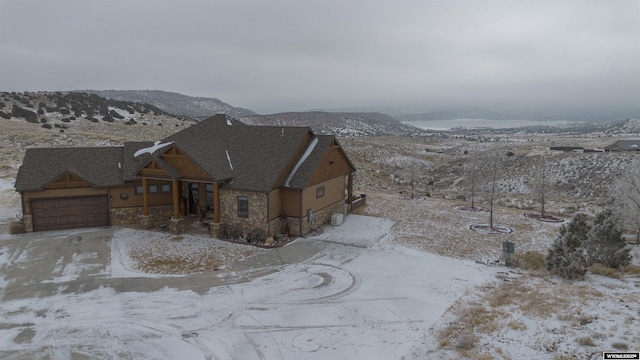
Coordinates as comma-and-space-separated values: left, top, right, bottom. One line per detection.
220, 189, 271, 235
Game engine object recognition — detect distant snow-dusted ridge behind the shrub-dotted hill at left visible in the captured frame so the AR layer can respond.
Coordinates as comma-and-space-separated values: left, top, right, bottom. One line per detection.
78, 90, 256, 120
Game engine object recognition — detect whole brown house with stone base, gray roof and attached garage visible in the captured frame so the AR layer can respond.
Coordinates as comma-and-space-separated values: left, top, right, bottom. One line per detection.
15, 115, 355, 236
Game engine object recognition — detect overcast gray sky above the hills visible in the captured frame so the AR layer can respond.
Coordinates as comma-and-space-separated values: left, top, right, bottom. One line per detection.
0, 0, 640, 113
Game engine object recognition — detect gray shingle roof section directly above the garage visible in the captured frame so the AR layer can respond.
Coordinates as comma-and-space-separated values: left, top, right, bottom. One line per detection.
15, 147, 124, 191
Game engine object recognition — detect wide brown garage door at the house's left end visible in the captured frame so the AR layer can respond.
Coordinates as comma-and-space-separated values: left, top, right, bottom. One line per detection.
31, 195, 109, 231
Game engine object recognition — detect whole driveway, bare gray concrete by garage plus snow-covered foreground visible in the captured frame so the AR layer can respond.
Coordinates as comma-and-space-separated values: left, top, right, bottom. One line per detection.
0, 215, 497, 360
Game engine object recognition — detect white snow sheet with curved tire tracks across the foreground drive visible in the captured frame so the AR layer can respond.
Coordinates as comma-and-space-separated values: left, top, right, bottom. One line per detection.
0, 215, 499, 359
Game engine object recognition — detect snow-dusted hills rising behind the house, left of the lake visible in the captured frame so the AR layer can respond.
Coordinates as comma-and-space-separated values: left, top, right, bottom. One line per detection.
0, 90, 426, 136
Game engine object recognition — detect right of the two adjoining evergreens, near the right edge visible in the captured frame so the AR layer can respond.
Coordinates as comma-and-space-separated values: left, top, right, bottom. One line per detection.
585, 209, 631, 269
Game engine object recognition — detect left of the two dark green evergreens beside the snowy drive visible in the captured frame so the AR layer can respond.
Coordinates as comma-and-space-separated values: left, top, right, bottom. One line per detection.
545, 214, 591, 280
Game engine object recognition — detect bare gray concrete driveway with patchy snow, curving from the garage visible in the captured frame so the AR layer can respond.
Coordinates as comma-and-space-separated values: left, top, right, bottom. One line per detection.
0, 227, 328, 301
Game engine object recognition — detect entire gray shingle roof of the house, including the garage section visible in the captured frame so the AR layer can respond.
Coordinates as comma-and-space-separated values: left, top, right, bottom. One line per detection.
15, 115, 353, 192
